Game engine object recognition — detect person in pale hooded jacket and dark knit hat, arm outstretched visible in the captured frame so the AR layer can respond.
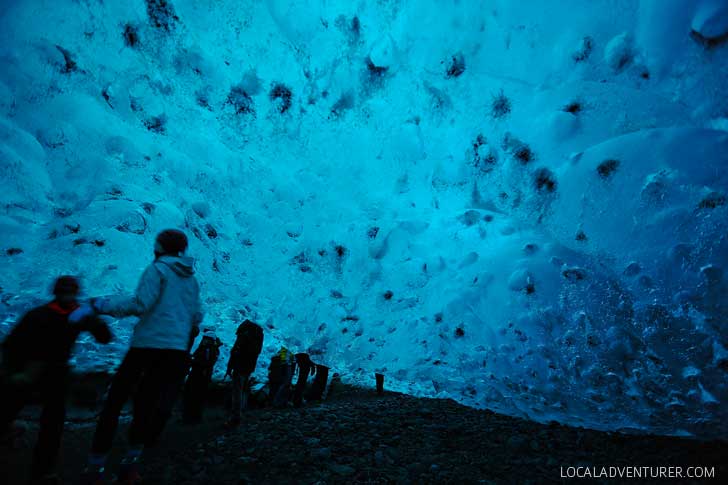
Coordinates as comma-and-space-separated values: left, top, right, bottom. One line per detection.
85, 229, 202, 483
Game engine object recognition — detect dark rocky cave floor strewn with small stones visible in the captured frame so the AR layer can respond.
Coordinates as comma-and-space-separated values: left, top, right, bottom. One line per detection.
0, 376, 728, 485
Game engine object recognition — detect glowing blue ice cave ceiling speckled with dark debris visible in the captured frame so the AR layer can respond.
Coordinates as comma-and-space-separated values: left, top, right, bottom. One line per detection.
0, 0, 728, 436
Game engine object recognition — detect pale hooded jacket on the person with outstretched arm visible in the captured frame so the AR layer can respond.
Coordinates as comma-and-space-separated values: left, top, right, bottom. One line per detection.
99, 255, 202, 351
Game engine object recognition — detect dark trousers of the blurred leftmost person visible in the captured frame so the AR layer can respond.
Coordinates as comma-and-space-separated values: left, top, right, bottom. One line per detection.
0, 366, 68, 478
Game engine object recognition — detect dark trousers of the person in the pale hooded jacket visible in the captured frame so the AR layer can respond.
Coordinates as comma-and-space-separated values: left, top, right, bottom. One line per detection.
91, 347, 189, 453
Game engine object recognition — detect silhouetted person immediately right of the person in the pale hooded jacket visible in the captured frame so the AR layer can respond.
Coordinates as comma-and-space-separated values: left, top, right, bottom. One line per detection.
182, 329, 222, 424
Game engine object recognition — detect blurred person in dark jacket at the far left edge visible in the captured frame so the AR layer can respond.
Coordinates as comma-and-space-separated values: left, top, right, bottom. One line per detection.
0, 276, 111, 483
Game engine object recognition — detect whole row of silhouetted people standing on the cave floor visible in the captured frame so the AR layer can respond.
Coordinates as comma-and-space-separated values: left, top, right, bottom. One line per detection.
0, 229, 328, 484
